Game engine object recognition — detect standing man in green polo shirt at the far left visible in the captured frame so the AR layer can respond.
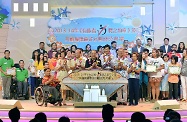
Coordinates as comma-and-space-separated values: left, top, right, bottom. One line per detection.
0, 50, 14, 99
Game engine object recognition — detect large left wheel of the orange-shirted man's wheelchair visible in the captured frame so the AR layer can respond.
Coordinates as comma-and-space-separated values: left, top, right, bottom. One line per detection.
35, 87, 45, 106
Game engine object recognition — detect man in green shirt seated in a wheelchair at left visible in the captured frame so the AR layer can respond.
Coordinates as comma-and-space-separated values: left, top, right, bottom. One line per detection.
14, 60, 28, 96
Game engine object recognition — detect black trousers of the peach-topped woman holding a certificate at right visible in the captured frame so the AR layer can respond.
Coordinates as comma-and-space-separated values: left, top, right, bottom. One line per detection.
169, 82, 178, 99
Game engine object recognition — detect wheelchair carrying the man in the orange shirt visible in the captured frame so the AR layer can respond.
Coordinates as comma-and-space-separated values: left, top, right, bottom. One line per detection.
35, 84, 63, 107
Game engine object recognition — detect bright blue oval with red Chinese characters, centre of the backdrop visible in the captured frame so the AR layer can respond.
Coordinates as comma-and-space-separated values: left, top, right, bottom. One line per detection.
48, 18, 137, 49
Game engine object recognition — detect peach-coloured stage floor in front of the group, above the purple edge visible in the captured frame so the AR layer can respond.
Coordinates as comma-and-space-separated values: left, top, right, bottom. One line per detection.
1, 100, 187, 112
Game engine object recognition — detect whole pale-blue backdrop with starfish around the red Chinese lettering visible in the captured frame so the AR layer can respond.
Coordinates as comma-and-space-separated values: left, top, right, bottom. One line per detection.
47, 5, 153, 49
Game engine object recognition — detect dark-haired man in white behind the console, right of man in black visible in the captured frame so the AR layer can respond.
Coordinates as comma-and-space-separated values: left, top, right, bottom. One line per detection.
100, 44, 114, 70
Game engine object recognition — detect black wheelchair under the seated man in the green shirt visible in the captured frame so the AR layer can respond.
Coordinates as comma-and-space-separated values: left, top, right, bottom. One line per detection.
10, 79, 30, 100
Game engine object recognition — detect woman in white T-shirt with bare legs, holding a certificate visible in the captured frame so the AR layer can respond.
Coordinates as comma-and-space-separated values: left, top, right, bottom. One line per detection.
149, 49, 164, 102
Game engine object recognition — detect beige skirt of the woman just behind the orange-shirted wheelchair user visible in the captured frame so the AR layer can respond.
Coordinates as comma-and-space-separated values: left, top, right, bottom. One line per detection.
57, 71, 69, 90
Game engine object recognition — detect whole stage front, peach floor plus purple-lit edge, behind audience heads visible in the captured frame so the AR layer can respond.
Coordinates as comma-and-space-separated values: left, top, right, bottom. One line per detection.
0, 100, 187, 122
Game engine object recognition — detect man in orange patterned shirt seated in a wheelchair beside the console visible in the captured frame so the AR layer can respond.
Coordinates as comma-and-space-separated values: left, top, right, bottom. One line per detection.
42, 68, 60, 100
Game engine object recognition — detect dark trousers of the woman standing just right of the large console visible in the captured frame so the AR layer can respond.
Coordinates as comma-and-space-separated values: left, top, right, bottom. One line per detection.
128, 78, 139, 105
